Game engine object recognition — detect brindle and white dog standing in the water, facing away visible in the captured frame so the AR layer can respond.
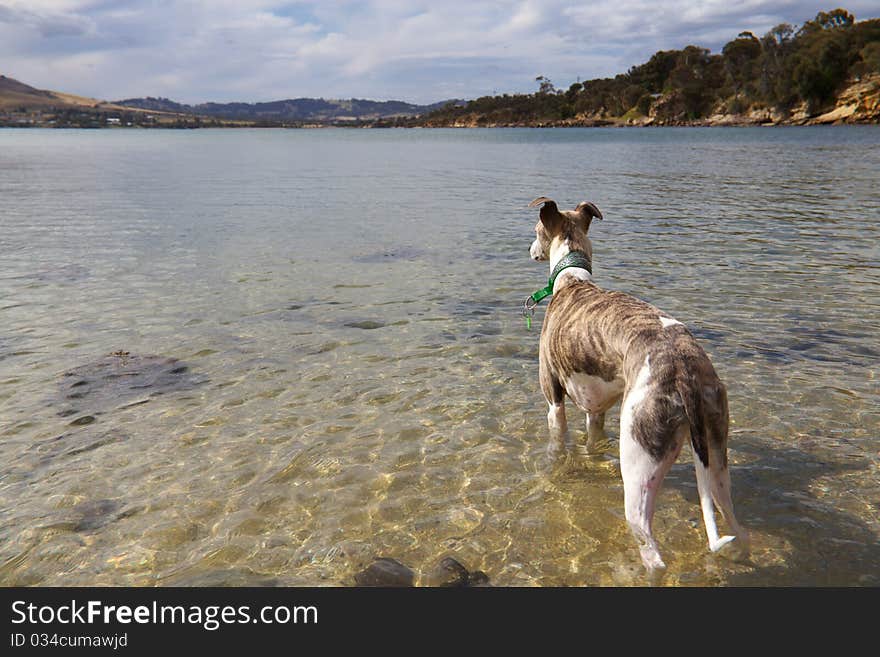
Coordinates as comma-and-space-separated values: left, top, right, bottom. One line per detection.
529, 196, 749, 574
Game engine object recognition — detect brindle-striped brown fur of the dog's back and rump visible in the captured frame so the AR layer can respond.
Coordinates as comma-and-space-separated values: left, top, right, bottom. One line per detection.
541, 281, 728, 465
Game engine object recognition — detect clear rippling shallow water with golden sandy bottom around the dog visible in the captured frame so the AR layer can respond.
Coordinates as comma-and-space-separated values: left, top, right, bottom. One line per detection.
0, 127, 880, 586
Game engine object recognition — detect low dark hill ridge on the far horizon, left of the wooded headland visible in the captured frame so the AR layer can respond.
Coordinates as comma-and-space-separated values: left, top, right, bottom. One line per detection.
115, 97, 456, 123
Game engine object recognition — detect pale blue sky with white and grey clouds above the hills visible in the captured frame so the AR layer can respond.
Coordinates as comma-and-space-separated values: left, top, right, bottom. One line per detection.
0, 0, 880, 103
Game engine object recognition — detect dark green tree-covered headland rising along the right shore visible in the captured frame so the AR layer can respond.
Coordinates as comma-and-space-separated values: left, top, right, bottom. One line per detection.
419, 9, 880, 125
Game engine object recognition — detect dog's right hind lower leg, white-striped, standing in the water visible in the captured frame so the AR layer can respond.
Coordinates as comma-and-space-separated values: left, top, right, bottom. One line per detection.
694, 449, 749, 559
